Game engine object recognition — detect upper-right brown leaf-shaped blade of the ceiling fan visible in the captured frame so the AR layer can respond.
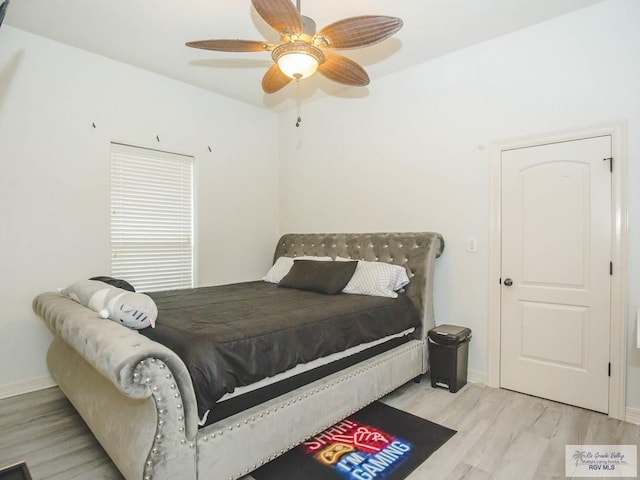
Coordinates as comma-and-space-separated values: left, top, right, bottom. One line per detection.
314, 15, 403, 49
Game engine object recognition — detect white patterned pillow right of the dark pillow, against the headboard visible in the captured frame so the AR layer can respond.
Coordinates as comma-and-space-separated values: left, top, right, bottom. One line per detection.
336, 257, 409, 298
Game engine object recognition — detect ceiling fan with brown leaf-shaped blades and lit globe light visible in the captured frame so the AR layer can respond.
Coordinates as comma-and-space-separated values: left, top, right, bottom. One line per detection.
187, 0, 402, 93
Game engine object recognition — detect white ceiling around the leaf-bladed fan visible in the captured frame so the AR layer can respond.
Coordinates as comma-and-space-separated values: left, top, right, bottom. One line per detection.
5, 0, 601, 111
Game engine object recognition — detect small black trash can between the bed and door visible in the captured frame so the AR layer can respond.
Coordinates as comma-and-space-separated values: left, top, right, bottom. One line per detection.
428, 325, 471, 393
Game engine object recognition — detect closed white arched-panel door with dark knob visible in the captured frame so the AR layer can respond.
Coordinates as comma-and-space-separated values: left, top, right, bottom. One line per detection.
500, 136, 612, 413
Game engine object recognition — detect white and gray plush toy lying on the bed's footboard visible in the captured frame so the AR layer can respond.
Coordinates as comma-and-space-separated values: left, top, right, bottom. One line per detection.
60, 280, 158, 330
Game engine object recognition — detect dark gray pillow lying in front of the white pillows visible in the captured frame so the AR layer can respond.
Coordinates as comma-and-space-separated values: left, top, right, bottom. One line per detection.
278, 260, 358, 295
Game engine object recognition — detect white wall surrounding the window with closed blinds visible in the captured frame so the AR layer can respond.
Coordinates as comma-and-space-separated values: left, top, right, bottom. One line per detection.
0, 25, 278, 397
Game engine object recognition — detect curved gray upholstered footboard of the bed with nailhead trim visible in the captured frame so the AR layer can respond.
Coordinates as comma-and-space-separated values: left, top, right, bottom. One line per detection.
33, 293, 197, 480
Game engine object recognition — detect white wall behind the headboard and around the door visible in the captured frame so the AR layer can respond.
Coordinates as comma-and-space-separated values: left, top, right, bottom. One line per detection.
280, 0, 640, 408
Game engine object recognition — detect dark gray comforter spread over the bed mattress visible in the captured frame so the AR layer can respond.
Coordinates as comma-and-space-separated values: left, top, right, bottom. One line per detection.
140, 281, 420, 418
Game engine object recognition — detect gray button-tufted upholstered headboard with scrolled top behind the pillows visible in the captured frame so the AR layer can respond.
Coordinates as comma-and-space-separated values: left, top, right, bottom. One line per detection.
273, 232, 444, 337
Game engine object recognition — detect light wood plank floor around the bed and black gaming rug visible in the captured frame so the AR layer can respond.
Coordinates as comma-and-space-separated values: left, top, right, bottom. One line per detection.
0, 379, 640, 480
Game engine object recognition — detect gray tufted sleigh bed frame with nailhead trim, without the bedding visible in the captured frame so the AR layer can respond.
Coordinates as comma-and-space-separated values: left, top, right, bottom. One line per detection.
33, 232, 444, 480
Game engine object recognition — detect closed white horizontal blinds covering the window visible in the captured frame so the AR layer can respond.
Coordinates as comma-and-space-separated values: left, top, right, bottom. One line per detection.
111, 143, 193, 292
